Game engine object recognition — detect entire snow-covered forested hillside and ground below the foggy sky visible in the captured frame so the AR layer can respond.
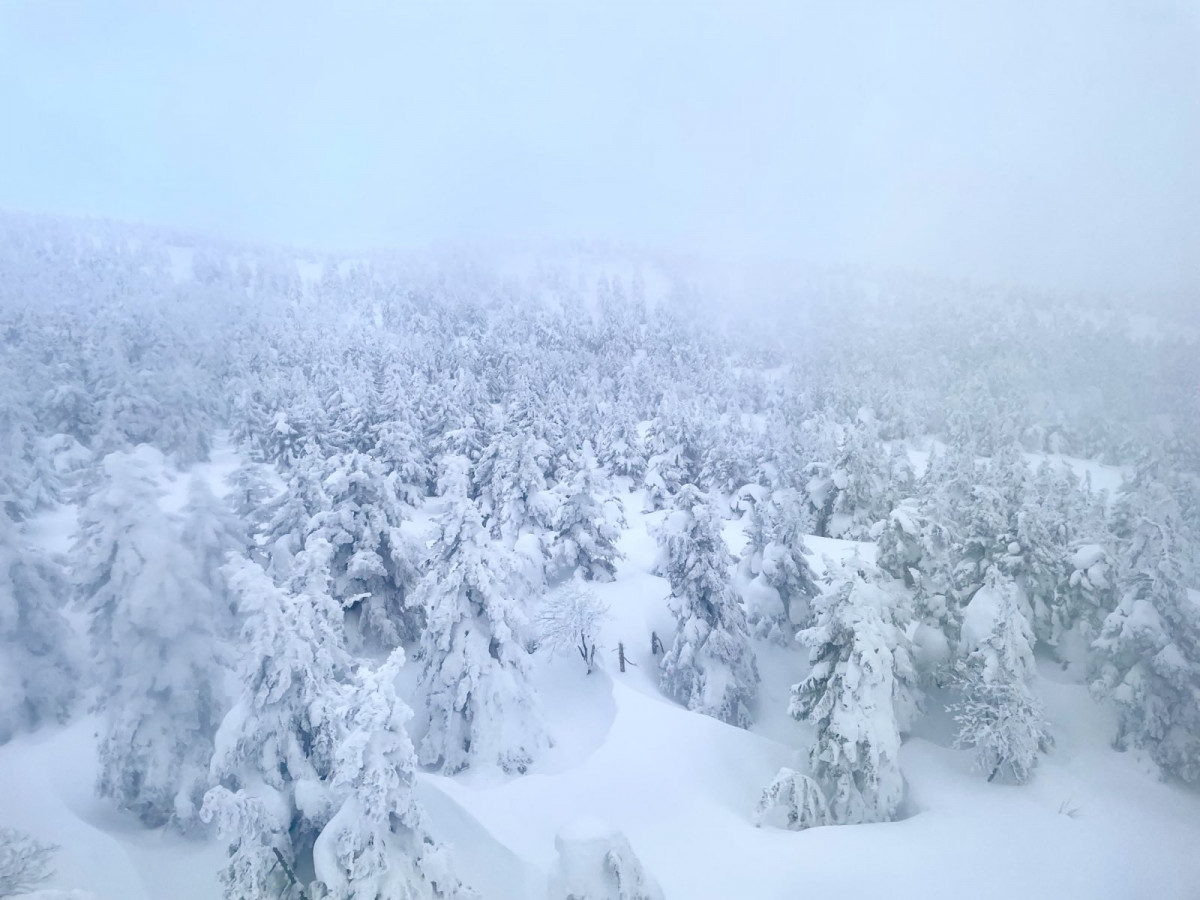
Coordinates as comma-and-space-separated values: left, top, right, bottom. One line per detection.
0, 215, 1200, 900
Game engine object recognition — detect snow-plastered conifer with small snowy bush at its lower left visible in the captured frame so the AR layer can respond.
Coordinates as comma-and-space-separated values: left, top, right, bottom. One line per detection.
790, 572, 917, 824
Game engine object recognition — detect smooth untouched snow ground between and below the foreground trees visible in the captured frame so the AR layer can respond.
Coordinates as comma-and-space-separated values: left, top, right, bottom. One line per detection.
0, 445, 1200, 900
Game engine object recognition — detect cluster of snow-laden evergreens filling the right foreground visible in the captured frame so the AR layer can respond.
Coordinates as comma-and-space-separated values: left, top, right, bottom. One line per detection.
768, 434, 1200, 827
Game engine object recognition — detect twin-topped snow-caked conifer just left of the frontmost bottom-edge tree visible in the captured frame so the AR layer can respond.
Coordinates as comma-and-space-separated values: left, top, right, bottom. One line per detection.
202, 539, 352, 900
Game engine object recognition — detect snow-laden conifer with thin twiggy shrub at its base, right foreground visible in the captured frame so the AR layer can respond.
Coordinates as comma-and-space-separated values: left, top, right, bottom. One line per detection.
950, 568, 1051, 784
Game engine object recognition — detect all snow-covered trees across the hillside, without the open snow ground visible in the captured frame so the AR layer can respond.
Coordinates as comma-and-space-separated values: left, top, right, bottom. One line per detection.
0, 210, 1200, 883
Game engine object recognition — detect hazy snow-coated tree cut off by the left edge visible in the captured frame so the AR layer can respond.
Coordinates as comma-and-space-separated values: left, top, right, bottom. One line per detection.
0, 506, 80, 744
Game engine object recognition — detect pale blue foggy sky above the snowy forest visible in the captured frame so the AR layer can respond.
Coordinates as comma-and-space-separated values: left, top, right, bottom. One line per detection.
0, 0, 1200, 292
